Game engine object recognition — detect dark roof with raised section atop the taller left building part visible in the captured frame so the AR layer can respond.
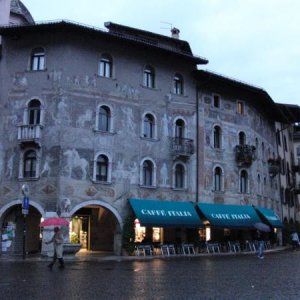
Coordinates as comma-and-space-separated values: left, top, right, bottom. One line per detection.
0, 20, 208, 64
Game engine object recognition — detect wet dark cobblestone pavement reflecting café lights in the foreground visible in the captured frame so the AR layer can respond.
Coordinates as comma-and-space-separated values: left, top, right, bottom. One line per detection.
0, 250, 300, 300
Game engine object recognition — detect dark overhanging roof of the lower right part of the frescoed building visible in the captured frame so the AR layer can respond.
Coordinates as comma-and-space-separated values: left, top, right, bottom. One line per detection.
194, 70, 286, 122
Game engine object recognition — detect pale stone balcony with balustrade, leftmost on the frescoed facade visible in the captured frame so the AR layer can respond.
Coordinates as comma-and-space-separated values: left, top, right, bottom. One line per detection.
18, 124, 43, 147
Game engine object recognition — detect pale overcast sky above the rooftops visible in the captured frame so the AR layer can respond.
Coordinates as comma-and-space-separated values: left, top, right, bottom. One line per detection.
22, 0, 300, 105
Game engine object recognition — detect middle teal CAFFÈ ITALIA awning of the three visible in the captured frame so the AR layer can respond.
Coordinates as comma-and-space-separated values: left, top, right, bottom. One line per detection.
198, 203, 261, 229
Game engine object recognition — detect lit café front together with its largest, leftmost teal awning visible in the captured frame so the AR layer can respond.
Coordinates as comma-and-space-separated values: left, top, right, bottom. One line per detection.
129, 199, 203, 250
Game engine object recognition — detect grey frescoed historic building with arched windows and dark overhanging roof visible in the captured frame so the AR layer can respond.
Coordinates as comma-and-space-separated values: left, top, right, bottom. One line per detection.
0, 1, 300, 253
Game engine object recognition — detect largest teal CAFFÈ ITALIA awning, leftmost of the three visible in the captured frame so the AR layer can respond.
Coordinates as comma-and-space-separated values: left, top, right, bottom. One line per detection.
128, 199, 203, 228
